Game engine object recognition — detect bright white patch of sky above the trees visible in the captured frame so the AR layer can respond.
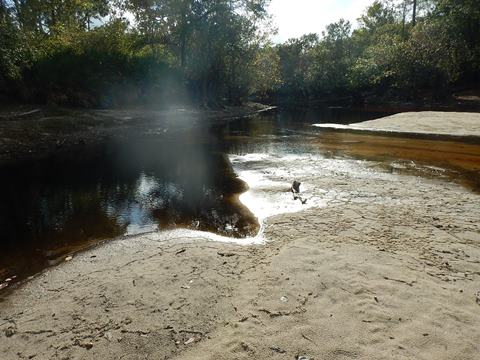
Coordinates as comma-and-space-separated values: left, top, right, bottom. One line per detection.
270, 0, 373, 42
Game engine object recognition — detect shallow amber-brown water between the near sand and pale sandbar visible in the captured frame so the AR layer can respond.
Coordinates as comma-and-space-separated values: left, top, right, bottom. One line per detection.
314, 132, 480, 192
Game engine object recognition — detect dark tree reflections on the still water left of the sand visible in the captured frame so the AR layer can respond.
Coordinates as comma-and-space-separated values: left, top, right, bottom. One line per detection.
0, 135, 259, 282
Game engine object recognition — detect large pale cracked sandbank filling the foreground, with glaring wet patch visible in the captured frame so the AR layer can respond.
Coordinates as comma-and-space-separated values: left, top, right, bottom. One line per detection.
0, 111, 480, 359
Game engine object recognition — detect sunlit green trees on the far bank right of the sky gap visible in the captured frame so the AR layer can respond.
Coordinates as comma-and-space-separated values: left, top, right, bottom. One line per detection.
261, 0, 480, 103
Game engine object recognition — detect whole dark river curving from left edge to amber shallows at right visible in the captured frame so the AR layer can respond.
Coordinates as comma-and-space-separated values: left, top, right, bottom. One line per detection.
0, 108, 480, 283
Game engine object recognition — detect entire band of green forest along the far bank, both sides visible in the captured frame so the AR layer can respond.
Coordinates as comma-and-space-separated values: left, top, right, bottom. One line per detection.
0, 0, 480, 108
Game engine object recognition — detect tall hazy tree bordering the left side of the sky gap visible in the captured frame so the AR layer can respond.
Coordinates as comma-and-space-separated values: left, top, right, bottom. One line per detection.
125, 0, 268, 105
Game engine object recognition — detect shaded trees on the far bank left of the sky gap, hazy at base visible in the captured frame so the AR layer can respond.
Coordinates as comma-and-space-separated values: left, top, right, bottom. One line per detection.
0, 0, 267, 107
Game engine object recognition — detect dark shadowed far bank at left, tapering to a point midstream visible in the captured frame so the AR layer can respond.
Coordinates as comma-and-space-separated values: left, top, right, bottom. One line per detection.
0, 103, 276, 164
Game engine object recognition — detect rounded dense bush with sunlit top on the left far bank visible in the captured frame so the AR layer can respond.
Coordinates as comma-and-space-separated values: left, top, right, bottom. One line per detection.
29, 21, 181, 106
